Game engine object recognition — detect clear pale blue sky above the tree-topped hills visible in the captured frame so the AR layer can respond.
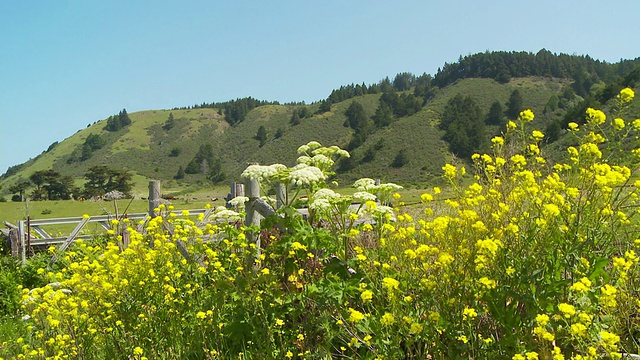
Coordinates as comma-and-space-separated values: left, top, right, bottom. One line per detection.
0, 0, 640, 173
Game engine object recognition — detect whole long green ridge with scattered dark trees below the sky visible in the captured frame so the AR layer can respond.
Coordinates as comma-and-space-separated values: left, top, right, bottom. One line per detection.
0, 49, 640, 195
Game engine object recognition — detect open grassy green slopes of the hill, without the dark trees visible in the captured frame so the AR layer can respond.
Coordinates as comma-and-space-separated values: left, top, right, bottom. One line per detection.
0, 77, 584, 196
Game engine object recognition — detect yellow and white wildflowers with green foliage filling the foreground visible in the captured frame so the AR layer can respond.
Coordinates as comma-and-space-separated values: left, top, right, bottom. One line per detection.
0, 89, 640, 359
